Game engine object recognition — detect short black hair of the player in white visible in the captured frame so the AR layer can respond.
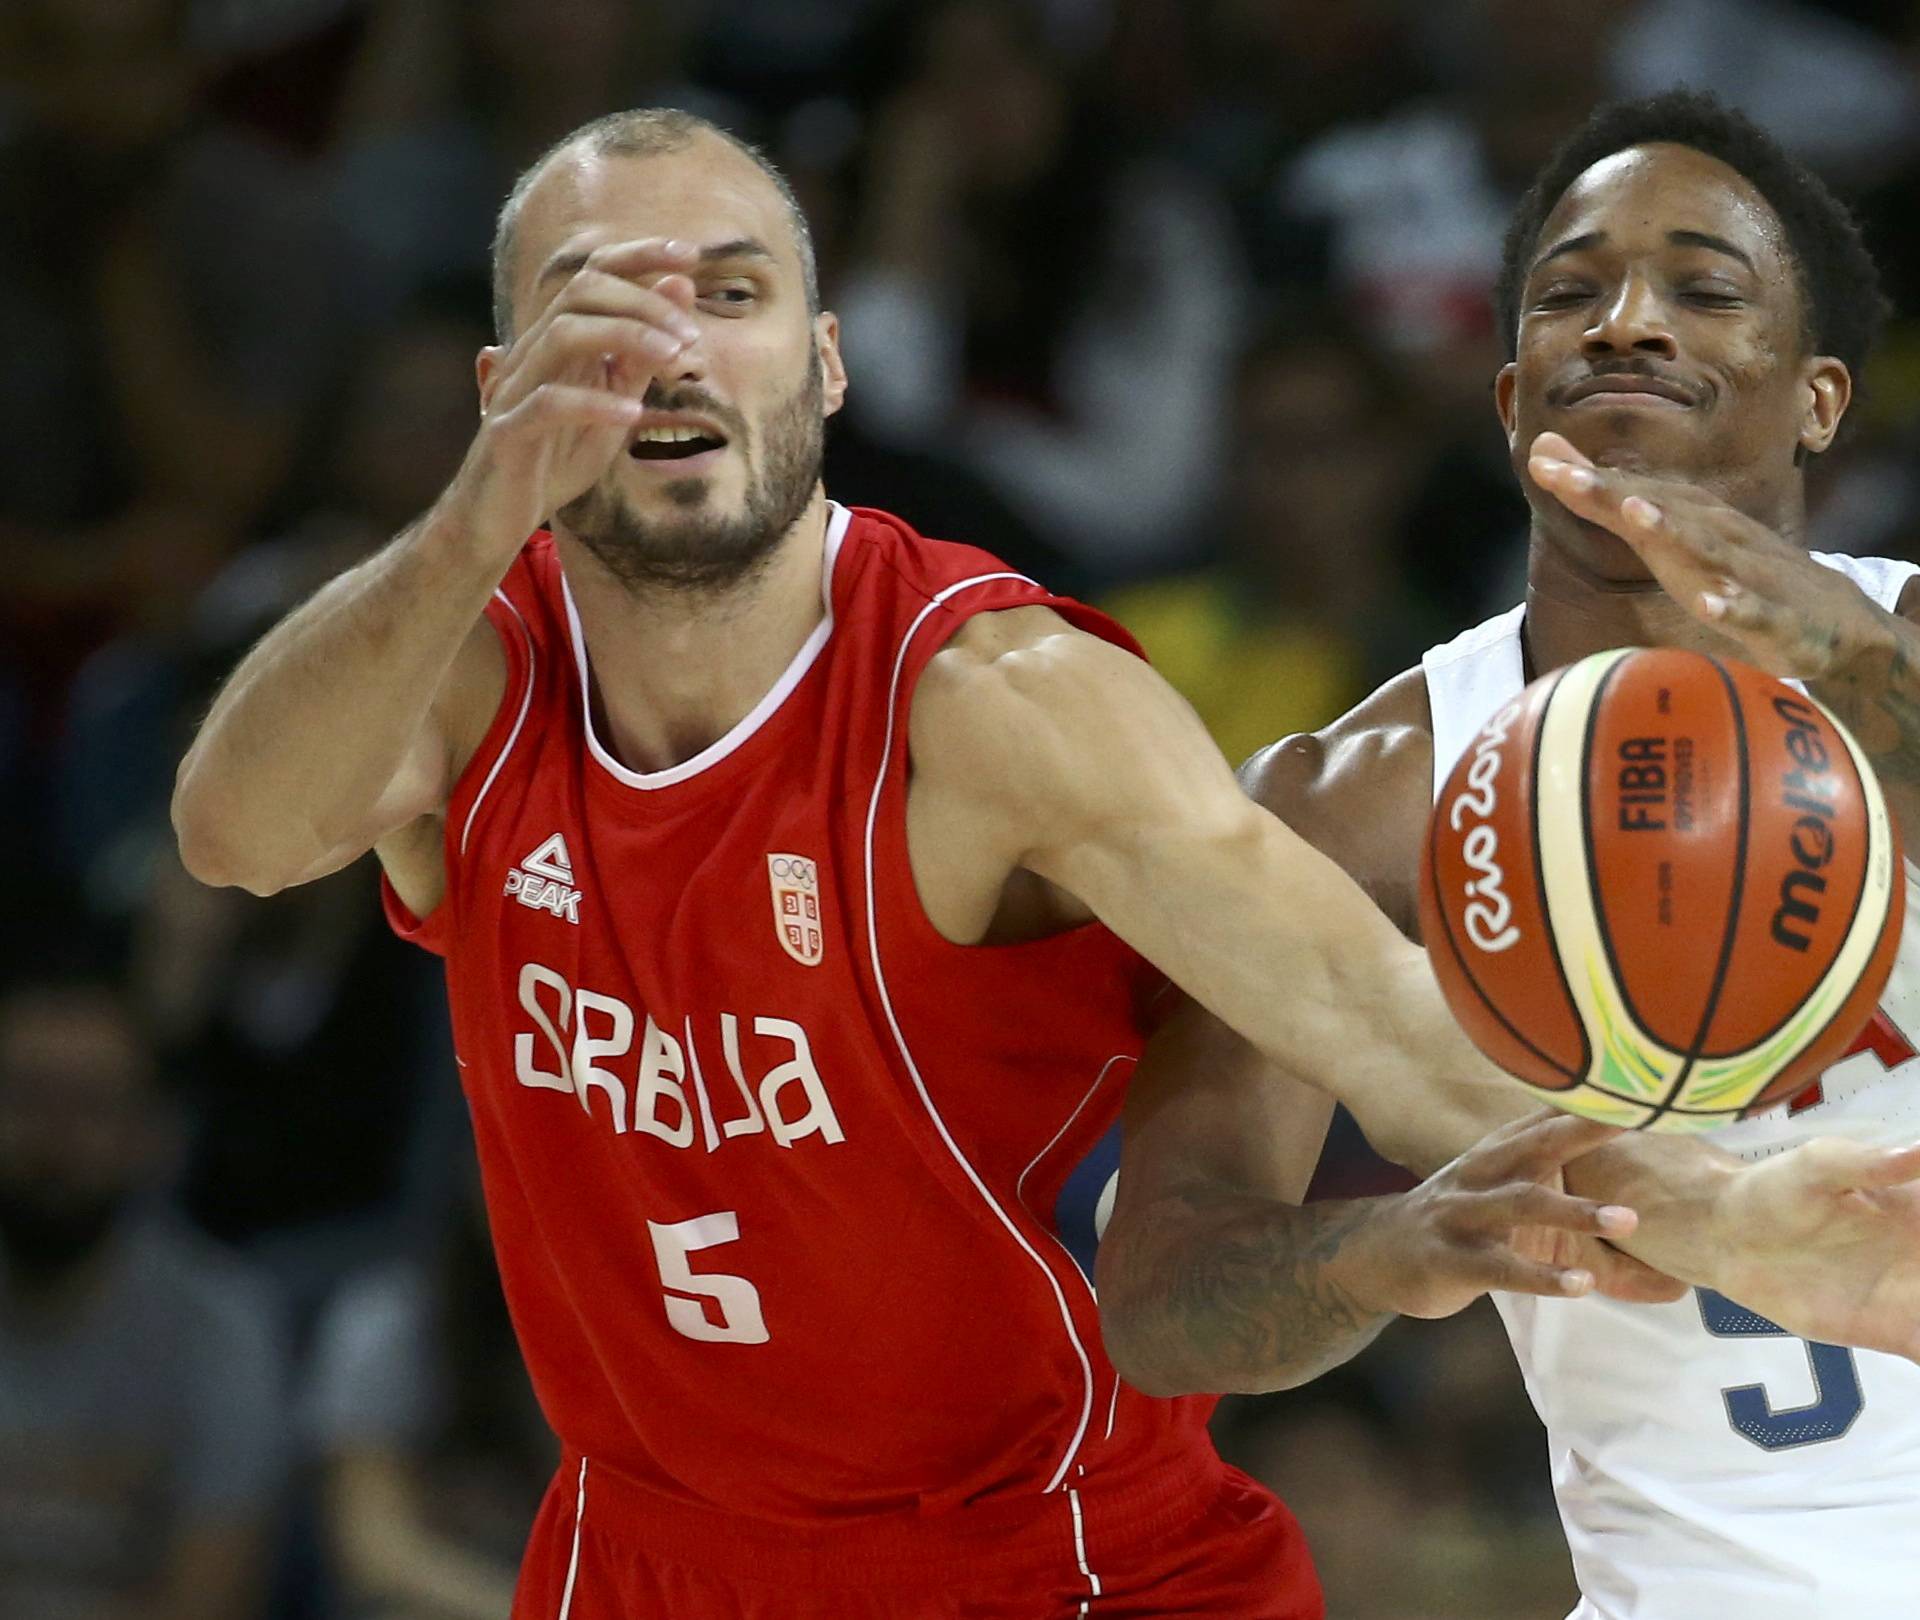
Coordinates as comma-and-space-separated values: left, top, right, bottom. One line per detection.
1494, 88, 1889, 374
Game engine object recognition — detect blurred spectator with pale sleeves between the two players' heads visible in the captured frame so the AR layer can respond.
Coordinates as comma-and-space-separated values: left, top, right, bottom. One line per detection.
833, 0, 1242, 580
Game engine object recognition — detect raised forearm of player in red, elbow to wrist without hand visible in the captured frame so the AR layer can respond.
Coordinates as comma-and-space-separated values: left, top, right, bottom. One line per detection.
173, 516, 505, 893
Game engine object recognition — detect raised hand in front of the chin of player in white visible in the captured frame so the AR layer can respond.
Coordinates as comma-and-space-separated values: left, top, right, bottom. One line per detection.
1526, 434, 1891, 681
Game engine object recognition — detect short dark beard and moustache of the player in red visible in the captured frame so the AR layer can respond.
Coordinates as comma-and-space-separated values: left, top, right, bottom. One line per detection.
557, 357, 826, 593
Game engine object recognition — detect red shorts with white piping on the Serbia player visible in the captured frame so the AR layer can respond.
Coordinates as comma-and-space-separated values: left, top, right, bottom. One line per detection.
513, 1459, 1327, 1620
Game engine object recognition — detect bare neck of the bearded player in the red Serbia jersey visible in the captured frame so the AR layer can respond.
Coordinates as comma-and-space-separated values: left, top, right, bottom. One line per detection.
555, 486, 828, 772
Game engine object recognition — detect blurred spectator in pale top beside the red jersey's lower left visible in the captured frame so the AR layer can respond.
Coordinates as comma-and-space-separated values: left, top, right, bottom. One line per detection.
307, 1188, 559, 1620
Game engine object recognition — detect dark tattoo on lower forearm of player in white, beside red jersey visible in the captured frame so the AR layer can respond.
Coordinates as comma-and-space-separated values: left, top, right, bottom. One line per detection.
1116, 1194, 1390, 1392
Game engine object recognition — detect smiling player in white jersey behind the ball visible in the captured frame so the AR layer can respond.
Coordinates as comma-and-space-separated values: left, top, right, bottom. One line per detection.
1098, 92, 1920, 1620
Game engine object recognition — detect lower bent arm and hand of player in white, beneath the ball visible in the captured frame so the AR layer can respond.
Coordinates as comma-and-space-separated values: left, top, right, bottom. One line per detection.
1098, 1004, 1678, 1395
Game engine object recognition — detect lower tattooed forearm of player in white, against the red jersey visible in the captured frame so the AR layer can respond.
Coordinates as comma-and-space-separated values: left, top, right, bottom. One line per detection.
1098, 1192, 1390, 1395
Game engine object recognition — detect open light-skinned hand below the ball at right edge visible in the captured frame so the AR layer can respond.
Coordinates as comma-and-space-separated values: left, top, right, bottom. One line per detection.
1713, 1136, 1920, 1361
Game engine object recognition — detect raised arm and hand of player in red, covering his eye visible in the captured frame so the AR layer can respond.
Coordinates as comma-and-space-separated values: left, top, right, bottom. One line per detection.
173, 242, 699, 910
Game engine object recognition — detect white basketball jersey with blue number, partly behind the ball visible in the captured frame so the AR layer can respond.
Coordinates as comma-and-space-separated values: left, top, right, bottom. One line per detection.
1421, 553, 1920, 1620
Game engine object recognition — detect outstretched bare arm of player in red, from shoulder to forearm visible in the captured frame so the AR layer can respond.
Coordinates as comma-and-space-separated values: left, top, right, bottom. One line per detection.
912, 608, 1521, 1143
